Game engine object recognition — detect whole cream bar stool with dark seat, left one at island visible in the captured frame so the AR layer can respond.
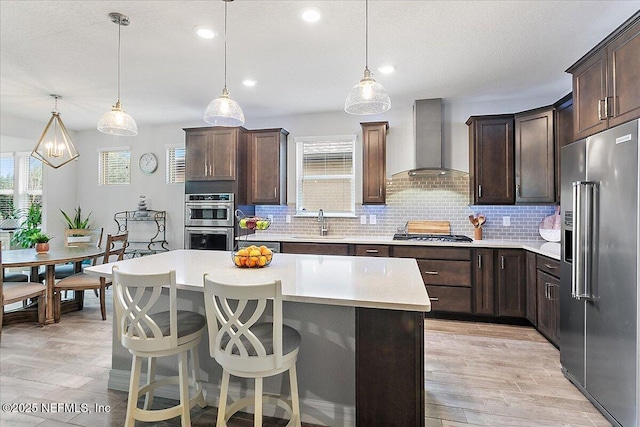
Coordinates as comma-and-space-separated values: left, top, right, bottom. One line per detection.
112, 266, 207, 427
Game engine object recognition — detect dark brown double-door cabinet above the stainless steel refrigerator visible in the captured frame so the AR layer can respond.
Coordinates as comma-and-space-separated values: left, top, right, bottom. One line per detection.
567, 12, 640, 140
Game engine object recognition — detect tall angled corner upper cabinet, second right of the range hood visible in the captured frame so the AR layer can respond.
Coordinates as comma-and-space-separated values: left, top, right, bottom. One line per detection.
515, 107, 556, 204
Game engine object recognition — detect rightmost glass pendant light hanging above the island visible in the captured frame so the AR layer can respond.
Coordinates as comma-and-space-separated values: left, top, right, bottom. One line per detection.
344, 0, 391, 115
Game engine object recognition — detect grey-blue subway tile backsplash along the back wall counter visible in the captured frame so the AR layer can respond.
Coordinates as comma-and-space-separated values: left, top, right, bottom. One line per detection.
256, 175, 555, 240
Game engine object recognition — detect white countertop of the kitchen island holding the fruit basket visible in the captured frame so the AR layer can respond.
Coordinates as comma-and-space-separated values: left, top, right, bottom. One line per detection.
84, 250, 431, 311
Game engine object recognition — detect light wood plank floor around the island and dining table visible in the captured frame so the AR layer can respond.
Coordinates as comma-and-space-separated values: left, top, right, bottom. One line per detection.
0, 291, 610, 427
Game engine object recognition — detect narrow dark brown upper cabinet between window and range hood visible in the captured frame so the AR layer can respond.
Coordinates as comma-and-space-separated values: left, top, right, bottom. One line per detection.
360, 122, 389, 205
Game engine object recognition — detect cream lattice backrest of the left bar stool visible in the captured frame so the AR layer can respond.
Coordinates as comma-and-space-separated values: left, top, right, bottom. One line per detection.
112, 266, 178, 352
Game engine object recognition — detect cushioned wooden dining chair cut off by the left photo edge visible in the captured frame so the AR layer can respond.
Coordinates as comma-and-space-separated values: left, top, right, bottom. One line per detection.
0, 249, 47, 339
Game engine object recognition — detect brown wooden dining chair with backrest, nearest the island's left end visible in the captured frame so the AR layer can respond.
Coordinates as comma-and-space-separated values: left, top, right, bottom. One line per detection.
53, 232, 128, 322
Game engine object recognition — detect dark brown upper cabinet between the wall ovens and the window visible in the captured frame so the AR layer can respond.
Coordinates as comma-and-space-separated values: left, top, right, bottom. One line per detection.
247, 128, 289, 205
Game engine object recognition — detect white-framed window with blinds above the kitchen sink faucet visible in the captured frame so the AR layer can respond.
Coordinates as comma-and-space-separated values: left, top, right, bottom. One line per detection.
295, 135, 356, 216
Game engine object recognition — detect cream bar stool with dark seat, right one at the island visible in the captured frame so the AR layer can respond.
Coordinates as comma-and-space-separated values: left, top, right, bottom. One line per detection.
204, 274, 301, 427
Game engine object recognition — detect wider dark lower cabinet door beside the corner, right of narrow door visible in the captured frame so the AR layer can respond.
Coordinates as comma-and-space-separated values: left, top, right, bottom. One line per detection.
498, 249, 527, 317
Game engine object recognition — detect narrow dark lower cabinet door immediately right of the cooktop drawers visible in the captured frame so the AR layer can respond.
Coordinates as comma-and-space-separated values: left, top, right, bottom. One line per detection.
473, 249, 496, 315
